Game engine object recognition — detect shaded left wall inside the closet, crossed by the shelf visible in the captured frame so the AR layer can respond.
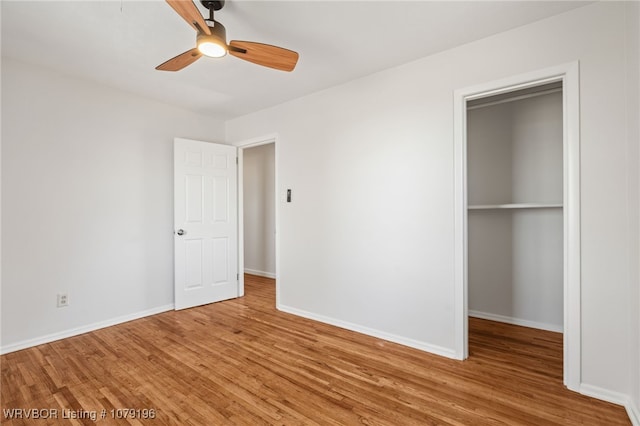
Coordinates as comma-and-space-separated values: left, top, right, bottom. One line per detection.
467, 103, 515, 324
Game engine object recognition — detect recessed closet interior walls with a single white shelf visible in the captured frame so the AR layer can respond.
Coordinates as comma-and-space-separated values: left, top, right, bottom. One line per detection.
467, 82, 564, 331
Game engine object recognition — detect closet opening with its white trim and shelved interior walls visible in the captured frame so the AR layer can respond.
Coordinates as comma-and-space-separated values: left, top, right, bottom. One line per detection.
454, 63, 581, 390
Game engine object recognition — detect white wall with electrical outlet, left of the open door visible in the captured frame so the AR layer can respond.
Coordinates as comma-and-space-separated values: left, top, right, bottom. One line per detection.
1, 58, 224, 351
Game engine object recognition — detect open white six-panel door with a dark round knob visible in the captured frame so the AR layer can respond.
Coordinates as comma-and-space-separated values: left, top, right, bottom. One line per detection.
174, 138, 239, 310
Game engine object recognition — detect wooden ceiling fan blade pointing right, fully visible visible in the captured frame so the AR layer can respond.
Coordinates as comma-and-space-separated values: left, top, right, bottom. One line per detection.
229, 40, 298, 71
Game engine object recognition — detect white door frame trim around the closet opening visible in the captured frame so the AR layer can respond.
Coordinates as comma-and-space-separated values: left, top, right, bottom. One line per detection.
453, 61, 582, 391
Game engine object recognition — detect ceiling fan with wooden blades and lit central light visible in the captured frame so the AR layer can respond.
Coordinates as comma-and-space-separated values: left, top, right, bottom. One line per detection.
156, 0, 298, 71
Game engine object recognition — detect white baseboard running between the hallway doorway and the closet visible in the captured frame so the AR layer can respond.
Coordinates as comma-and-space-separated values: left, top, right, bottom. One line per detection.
277, 305, 458, 359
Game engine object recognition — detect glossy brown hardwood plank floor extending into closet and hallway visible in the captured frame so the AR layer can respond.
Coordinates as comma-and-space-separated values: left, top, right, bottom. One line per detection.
0, 275, 630, 426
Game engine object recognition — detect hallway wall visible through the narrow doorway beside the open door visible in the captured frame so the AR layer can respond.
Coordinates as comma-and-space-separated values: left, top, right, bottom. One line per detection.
243, 143, 276, 278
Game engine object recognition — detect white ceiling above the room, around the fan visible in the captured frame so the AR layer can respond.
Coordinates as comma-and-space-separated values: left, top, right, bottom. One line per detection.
0, 0, 588, 119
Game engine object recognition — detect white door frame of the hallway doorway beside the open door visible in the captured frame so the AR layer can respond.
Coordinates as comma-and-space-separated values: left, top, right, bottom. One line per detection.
231, 133, 280, 306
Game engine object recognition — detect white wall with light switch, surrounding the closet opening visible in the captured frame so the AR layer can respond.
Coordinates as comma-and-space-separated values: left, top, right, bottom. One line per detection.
227, 2, 637, 400
